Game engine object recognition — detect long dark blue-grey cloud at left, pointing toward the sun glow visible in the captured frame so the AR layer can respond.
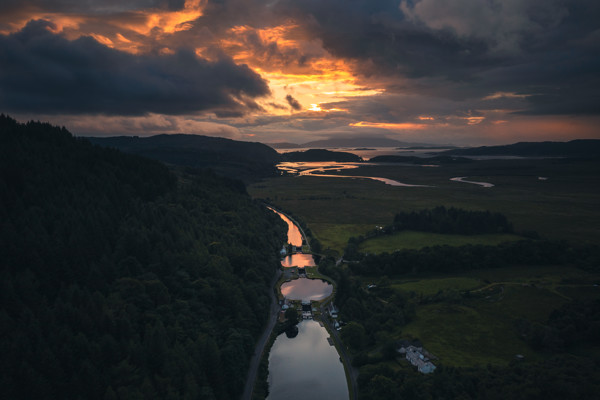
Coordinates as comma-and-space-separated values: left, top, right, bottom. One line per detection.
0, 21, 269, 115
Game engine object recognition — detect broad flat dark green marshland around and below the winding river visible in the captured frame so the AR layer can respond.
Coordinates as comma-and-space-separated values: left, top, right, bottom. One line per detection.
248, 159, 600, 248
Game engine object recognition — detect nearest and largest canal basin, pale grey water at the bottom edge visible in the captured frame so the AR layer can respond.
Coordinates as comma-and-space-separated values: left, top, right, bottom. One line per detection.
267, 320, 349, 400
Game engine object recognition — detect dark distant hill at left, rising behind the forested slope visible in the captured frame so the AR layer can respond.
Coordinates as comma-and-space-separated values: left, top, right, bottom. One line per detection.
88, 134, 280, 181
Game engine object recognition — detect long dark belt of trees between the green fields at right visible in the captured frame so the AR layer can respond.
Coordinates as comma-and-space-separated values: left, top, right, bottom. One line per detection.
349, 240, 600, 278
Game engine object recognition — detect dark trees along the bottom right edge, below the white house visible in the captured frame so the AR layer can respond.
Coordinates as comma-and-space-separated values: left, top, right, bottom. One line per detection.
358, 355, 600, 400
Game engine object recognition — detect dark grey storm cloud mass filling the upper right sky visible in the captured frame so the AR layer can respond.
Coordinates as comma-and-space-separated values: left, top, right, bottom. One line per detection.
277, 0, 600, 114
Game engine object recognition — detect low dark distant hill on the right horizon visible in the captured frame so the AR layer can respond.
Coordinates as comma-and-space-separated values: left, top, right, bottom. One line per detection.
440, 139, 600, 157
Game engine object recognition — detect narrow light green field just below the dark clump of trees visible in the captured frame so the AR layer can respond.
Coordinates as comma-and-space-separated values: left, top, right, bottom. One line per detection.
359, 231, 522, 253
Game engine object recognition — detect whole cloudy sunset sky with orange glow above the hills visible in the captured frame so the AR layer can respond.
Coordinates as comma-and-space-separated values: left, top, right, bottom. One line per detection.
0, 0, 600, 145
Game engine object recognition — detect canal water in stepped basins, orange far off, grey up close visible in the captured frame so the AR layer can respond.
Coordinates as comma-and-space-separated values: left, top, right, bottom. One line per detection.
267, 209, 349, 400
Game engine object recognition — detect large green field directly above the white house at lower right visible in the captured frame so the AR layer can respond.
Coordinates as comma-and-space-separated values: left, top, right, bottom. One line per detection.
402, 286, 567, 366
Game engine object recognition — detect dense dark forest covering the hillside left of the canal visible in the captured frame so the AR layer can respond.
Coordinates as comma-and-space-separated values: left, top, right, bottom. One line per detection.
0, 115, 286, 400
